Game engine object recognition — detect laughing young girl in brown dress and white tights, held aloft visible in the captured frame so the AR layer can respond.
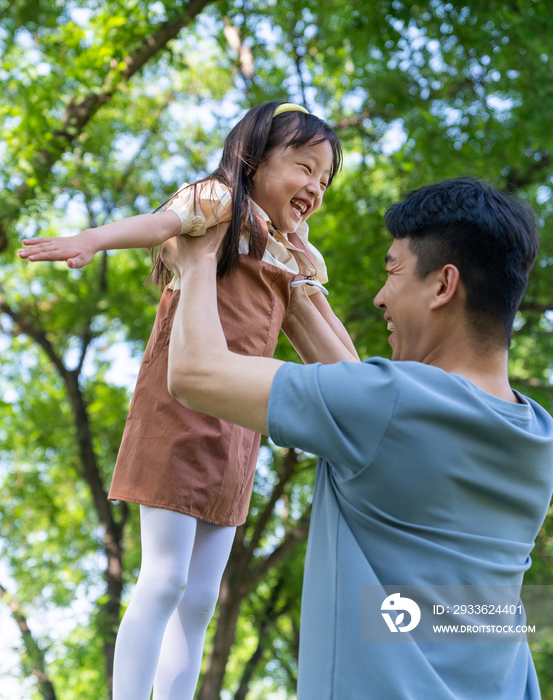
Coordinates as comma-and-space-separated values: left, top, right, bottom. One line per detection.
20, 102, 356, 700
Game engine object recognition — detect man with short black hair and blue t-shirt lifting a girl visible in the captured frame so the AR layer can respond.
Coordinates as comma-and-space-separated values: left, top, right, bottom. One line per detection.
164, 178, 553, 700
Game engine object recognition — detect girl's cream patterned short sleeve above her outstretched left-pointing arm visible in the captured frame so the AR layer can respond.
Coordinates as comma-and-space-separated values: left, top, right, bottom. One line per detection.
165, 181, 232, 236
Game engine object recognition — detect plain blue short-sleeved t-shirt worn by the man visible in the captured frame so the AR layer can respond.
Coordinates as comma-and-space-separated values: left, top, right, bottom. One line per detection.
268, 357, 553, 700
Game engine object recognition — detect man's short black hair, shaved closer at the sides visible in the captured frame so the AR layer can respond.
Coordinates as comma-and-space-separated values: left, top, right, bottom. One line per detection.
384, 177, 539, 347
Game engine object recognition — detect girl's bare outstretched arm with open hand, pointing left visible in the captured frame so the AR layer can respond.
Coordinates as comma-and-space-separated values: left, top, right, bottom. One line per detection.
18, 210, 181, 268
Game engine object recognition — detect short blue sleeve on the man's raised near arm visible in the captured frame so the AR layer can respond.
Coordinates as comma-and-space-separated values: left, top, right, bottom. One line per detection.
267, 358, 399, 471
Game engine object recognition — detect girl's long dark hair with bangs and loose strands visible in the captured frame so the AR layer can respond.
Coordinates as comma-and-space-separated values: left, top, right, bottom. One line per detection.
148, 102, 342, 288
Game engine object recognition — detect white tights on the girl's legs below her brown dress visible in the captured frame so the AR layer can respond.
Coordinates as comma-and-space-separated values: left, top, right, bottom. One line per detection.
113, 506, 236, 700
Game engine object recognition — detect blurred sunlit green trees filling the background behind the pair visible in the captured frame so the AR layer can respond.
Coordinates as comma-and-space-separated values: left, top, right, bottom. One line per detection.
0, 0, 553, 700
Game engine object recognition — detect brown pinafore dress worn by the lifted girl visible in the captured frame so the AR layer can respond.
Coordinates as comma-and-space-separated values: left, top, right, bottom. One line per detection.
108, 238, 310, 526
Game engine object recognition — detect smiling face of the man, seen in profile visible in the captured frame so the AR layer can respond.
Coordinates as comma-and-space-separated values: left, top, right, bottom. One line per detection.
374, 238, 436, 362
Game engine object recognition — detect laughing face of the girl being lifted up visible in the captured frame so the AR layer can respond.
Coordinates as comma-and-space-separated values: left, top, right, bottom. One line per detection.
252, 141, 332, 233
